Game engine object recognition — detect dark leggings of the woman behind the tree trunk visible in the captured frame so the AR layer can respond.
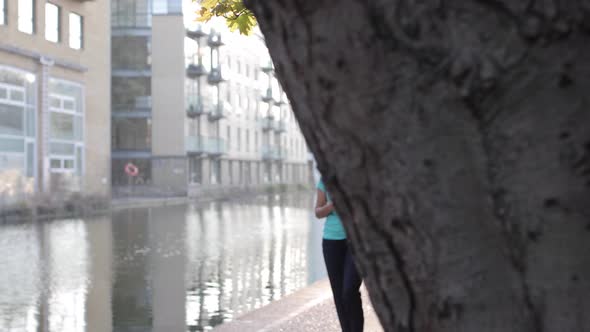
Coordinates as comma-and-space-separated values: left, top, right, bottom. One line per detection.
322, 239, 365, 332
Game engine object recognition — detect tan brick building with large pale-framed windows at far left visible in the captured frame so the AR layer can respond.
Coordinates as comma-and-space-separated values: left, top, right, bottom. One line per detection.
0, 0, 110, 205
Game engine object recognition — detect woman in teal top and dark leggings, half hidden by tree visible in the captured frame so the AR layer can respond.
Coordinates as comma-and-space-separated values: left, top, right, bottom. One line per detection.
315, 179, 364, 332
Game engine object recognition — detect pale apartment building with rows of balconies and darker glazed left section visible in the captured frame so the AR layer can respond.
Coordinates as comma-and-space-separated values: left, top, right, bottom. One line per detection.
112, 0, 310, 195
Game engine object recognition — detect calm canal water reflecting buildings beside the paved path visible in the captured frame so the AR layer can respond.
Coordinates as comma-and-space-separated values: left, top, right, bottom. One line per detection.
0, 193, 325, 332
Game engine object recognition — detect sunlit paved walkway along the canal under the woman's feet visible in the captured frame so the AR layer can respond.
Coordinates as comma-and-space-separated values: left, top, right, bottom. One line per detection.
213, 279, 383, 332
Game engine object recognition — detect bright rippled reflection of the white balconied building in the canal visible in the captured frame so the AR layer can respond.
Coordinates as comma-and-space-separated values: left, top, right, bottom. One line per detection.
186, 196, 325, 331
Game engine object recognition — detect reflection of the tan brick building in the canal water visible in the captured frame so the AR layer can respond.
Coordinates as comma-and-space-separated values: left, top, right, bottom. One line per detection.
0, 220, 111, 332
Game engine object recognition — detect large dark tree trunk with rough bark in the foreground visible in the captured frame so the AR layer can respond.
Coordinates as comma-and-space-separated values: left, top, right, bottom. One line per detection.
245, 0, 590, 332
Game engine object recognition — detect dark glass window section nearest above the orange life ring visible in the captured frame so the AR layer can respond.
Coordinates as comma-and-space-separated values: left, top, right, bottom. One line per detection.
111, 117, 152, 151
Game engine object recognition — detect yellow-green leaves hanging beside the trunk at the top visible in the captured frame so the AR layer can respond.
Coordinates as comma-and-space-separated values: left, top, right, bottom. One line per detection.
194, 0, 256, 35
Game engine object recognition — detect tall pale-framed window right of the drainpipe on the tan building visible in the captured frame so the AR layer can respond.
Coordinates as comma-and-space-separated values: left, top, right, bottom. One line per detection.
49, 79, 84, 176
